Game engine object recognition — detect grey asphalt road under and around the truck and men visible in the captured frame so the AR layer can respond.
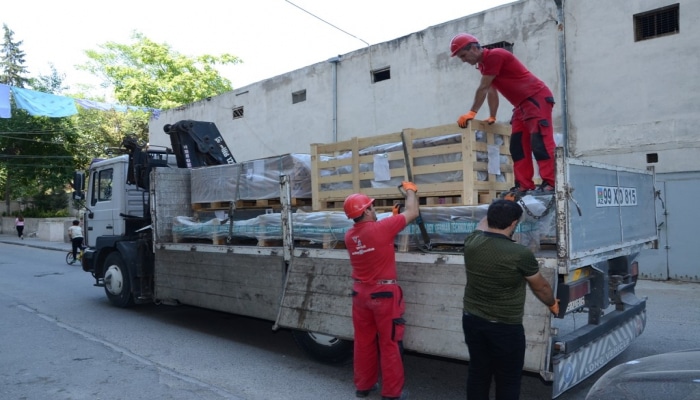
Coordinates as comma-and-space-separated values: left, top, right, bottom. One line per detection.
0, 238, 700, 400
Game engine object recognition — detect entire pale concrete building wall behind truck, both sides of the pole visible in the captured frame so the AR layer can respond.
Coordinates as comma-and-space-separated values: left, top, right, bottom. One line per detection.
150, 0, 700, 172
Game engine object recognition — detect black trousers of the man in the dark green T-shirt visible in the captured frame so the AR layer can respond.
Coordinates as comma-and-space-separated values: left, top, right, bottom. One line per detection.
462, 313, 525, 400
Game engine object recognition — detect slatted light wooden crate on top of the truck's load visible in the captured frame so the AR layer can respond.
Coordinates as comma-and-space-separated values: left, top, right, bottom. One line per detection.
311, 121, 514, 211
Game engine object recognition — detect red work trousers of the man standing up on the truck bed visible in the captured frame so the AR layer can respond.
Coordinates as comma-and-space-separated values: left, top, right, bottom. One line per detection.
510, 87, 555, 190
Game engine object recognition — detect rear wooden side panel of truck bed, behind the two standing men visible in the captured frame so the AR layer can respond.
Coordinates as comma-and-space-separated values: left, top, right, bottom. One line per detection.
277, 250, 555, 372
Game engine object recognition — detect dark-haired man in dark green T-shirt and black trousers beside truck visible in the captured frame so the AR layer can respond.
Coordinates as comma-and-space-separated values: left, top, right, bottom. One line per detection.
462, 200, 559, 400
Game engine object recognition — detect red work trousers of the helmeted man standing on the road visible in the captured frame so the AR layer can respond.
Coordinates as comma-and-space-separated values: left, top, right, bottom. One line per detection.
352, 283, 406, 397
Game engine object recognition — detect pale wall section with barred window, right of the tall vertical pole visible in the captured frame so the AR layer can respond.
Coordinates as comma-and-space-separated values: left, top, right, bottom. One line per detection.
565, 0, 700, 173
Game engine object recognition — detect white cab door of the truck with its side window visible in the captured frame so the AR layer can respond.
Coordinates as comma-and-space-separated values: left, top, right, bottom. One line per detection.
85, 164, 121, 242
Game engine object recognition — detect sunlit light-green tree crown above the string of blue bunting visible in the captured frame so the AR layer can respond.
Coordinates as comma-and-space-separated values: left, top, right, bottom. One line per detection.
79, 32, 241, 109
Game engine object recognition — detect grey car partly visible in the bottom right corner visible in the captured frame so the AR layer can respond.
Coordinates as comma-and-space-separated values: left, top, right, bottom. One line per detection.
586, 349, 700, 400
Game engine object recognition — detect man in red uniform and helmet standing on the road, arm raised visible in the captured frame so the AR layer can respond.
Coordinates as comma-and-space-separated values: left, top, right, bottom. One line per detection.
343, 182, 418, 400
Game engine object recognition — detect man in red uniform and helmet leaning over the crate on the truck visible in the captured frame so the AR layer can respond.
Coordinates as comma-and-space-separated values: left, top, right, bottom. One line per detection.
450, 33, 555, 195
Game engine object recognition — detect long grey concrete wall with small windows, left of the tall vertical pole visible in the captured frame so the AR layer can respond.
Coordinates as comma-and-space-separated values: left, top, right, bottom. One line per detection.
150, 0, 558, 161
